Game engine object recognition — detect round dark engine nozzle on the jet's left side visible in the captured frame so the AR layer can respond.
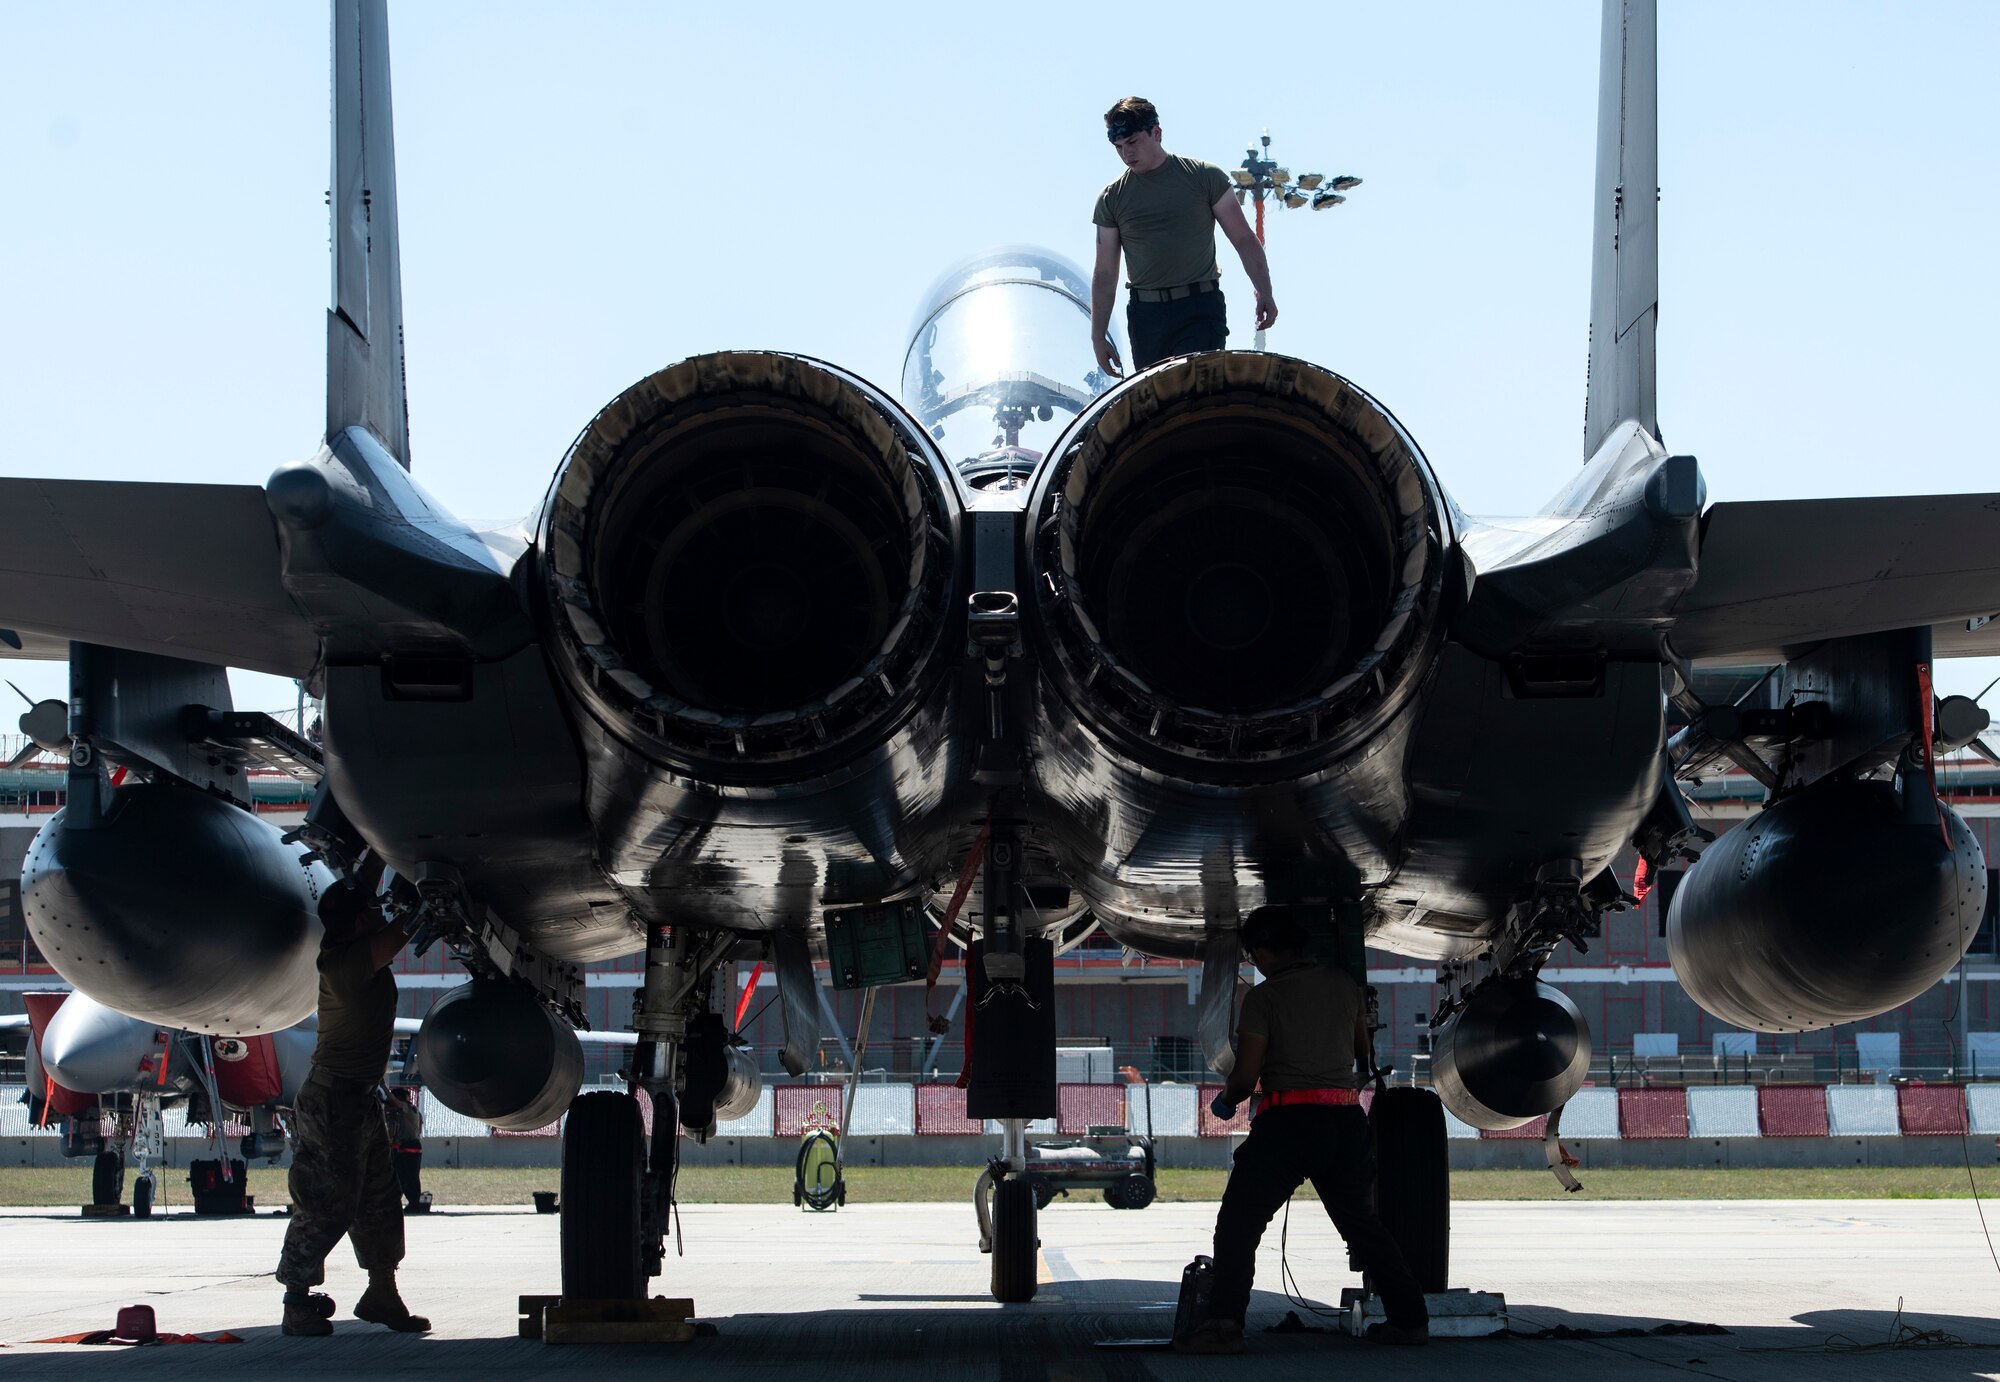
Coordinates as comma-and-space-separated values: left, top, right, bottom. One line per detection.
544, 352, 954, 772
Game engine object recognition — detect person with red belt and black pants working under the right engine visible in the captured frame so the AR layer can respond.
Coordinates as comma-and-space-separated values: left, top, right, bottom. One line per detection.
1174, 906, 1430, 1354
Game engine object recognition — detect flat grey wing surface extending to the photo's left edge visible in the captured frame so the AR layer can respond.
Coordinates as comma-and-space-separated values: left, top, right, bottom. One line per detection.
0, 480, 318, 678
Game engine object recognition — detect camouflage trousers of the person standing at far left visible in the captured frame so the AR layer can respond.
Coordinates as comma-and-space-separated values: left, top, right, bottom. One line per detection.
278, 1072, 402, 1290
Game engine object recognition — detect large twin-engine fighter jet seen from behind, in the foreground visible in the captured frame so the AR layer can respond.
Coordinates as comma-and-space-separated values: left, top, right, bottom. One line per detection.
0, 0, 2000, 1300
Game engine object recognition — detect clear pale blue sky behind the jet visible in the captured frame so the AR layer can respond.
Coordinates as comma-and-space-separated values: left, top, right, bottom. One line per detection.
0, 0, 2000, 722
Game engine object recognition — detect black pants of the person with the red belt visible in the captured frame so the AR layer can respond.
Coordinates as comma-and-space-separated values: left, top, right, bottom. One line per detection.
1208, 1104, 1428, 1326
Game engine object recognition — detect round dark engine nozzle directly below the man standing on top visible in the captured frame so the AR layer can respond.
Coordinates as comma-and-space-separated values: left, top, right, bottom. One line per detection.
1036, 352, 1446, 762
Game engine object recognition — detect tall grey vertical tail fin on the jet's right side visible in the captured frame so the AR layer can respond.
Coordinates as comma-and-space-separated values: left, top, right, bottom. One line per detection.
1584, 0, 1660, 458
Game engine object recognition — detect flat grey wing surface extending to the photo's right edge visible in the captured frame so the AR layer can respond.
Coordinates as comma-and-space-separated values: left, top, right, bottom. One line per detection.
1672, 494, 2000, 662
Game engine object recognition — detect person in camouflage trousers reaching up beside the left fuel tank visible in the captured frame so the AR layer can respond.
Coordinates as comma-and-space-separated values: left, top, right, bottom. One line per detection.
278, 860, 430, 1336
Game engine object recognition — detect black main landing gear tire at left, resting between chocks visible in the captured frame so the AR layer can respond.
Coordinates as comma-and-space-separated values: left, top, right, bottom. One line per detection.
560, 1090, 644, 1300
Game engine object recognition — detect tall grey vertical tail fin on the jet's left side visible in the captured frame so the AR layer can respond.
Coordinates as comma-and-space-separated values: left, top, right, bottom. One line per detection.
326, 0, 410, 470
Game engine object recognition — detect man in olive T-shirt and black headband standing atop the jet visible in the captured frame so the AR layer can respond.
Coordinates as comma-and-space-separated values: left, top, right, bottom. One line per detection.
1090, 96, 1278, 374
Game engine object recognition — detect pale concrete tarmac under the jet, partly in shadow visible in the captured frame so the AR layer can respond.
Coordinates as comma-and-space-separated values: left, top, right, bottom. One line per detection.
0, 1198, 2000, 1382
